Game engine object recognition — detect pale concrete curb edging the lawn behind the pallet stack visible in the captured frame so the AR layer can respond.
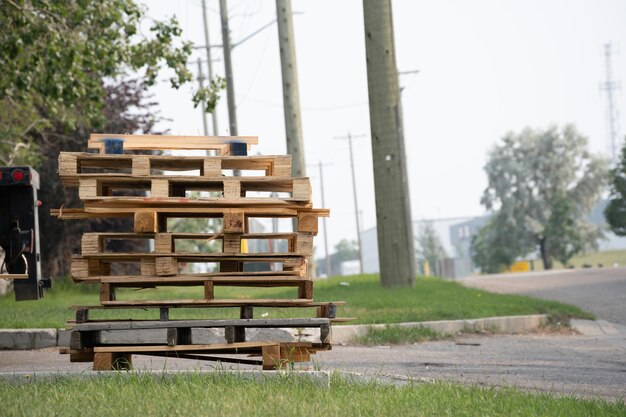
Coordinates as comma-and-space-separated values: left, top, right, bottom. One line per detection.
0, 314, 548, 350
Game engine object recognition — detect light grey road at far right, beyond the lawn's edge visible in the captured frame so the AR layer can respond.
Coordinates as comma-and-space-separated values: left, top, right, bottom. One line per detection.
459, 268, 626, 325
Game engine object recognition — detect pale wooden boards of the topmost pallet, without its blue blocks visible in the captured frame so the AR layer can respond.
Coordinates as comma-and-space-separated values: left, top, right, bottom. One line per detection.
87, 133, 259, 155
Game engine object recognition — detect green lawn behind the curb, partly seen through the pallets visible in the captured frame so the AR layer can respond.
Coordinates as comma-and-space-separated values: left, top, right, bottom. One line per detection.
0, 275, 593, 328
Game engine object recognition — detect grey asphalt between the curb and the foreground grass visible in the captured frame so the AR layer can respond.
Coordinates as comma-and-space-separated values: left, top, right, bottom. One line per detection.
0, 328, 626, 401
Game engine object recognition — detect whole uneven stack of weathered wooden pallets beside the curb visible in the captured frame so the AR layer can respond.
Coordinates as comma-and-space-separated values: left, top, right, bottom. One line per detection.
52, 135, 346, 369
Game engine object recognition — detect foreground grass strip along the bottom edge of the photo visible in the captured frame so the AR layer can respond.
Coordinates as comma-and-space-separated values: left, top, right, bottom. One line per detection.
0, 373, 626, 417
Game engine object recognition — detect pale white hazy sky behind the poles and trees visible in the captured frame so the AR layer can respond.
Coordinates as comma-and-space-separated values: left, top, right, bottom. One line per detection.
141, 0, 626, 253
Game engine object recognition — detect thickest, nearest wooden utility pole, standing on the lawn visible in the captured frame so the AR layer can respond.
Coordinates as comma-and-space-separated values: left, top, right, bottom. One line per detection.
363, 0, 416, 287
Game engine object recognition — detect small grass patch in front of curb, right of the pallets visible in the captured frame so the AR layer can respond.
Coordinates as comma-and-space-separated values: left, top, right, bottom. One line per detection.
353, 324, 450, 346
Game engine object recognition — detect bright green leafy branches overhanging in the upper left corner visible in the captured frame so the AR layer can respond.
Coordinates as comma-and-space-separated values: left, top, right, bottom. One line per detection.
0, 0, 223, 161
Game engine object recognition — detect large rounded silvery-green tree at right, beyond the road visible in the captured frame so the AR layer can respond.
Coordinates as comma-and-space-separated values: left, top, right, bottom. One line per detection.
473, 125, 607, 269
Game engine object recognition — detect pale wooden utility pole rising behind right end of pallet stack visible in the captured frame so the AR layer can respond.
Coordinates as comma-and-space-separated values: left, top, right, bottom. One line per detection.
276, 0, 306, 177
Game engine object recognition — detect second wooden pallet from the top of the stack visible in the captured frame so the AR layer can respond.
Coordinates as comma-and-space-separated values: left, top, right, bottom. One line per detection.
59, 152, 291, 187
